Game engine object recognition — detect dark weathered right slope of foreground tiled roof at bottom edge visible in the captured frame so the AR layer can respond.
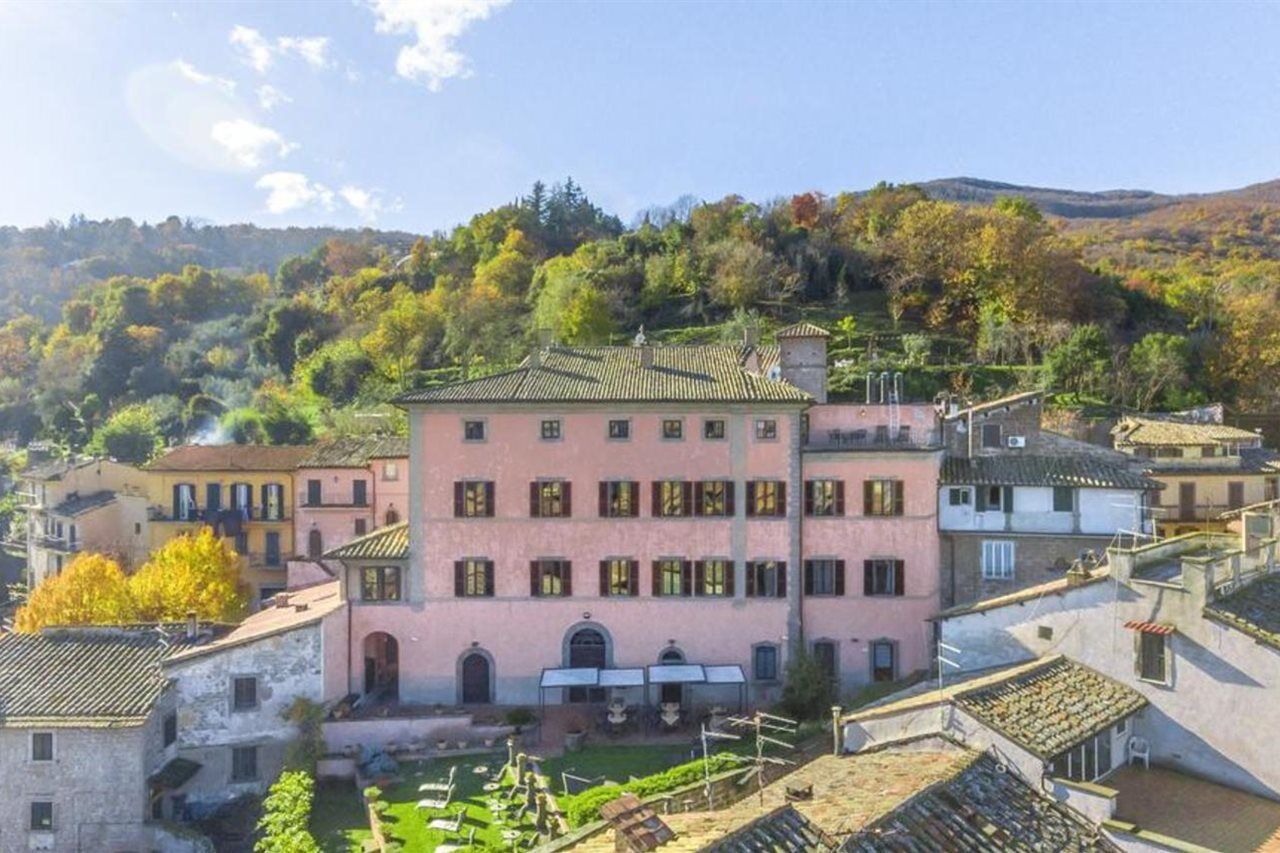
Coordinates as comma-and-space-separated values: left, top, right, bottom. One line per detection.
840, 753, 1119, 853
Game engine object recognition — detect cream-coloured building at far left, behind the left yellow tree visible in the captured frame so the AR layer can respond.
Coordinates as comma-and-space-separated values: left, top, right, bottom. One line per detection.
18, 457, 148, 587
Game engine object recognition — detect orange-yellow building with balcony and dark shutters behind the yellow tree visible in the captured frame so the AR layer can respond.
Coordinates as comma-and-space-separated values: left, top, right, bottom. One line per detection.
145, 444, 311, 602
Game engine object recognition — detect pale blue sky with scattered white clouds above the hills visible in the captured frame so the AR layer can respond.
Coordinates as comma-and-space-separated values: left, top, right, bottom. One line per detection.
0, 0, 1280, 231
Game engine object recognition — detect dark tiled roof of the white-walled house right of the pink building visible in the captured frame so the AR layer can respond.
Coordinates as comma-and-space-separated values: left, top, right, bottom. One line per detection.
940, 453, 1164, 489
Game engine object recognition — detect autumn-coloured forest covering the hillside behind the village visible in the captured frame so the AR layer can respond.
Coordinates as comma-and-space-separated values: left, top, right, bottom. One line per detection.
0, 179, 1280, 461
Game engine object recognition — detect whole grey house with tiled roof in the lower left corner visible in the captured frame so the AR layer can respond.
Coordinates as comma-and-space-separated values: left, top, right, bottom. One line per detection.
0, 625, 203, 853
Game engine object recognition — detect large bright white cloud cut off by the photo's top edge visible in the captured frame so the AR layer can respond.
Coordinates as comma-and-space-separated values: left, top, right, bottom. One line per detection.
366, 0, 511, 92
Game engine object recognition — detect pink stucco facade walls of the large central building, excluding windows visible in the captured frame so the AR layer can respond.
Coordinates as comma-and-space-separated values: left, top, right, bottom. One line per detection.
337, 391, 941, 704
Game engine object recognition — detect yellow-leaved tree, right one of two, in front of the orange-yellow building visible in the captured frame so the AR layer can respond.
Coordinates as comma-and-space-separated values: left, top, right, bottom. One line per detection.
129, 528, 246, 622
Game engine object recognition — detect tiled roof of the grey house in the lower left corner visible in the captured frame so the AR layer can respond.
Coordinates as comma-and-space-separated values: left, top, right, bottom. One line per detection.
0, 625, 188, 726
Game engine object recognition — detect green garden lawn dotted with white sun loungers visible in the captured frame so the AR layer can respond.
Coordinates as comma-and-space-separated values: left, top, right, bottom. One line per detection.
311, 756, 532, 853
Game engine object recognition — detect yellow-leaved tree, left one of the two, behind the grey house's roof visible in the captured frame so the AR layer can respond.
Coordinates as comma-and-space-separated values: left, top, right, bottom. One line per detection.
14, 553, 137, 633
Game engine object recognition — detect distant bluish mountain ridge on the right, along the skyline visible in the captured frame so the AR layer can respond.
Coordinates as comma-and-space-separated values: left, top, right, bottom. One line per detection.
916, 178, 1280, 219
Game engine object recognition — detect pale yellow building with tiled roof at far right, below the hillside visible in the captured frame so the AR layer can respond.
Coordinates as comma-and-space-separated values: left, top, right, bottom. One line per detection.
1111, 407, 1280, 535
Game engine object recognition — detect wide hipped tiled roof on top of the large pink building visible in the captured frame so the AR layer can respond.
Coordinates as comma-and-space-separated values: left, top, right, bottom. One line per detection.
396, 345, 812, 403
